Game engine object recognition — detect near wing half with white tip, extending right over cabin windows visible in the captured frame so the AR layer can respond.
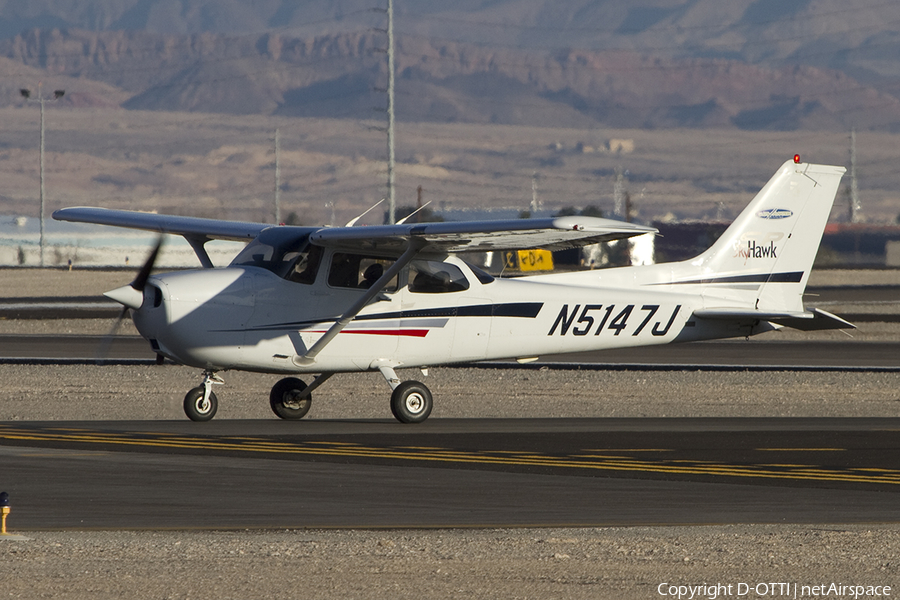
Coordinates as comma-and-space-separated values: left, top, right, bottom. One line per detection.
310, 217, 657, 254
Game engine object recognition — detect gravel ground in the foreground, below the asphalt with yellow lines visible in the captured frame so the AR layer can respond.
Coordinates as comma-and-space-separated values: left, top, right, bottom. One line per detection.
0, 525, 900, 600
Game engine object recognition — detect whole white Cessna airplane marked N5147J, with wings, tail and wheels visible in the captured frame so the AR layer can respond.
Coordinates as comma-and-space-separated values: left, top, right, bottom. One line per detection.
53, 156, 853, 423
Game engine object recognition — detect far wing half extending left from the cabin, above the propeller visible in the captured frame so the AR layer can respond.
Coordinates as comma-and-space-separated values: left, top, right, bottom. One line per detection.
53, 207, 271, 242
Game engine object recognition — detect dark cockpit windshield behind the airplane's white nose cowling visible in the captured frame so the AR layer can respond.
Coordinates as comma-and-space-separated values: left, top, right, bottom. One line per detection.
231, 227, 322, 283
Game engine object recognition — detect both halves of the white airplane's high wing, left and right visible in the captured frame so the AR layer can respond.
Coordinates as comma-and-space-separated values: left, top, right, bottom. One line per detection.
53, 207, 657, 261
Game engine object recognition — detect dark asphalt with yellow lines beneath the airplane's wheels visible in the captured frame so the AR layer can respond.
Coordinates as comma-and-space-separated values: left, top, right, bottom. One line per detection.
0, 418, 900, 530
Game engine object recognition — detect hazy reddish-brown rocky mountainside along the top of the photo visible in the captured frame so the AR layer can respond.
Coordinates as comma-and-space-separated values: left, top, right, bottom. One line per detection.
0, 0, 900, 130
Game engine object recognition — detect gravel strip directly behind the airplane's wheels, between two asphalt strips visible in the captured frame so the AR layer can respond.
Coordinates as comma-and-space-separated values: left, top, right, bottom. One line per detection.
0, 364, 900, 421
